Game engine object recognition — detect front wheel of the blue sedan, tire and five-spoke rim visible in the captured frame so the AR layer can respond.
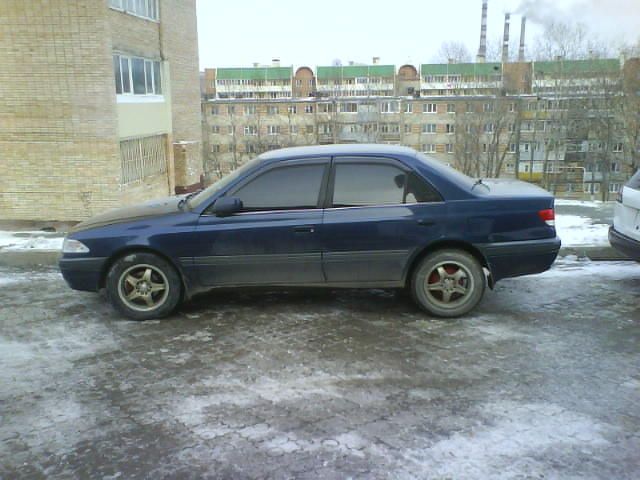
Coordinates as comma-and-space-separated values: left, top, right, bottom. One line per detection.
106, 252, 182, 320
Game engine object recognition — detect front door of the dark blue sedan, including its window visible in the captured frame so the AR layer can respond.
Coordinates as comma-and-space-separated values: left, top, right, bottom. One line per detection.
194, 159, 329, 286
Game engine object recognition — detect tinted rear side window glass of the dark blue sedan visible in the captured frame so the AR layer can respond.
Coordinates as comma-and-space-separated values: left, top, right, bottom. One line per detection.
333, 163, 441, 207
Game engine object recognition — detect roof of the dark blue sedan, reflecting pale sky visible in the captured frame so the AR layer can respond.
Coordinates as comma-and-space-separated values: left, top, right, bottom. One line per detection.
260, 143, 416, 161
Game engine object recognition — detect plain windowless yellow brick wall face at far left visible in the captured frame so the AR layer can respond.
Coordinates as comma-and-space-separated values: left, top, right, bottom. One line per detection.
0, 0, 119, 220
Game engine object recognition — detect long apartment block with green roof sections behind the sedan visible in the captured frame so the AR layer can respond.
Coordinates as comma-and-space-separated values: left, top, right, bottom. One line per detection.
202, 58, 640, 198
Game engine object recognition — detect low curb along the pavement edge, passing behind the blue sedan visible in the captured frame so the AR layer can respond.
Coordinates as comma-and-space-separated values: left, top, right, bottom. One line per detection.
0, 246, 632, 267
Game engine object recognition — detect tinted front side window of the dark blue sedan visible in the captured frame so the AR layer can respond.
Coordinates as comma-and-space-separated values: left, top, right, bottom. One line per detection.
231, 165, 325, 210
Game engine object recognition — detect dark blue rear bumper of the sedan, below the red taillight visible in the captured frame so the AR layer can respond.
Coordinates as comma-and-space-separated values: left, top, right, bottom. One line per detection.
476, 237, 561, 282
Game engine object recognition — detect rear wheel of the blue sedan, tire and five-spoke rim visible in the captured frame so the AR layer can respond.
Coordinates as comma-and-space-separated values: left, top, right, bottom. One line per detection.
410, 249, 486, 318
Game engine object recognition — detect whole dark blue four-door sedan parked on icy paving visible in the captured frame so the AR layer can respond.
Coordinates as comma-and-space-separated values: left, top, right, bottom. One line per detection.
60, 145, 560, 320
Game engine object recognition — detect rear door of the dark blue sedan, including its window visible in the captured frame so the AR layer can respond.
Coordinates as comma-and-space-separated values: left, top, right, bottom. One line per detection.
322, 157, 445, 285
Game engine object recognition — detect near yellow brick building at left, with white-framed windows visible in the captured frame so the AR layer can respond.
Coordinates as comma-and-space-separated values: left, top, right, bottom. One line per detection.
0, 0, 202, 220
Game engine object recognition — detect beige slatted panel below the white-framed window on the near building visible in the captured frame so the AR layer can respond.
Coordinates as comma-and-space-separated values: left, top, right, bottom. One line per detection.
120, 135, 167, 185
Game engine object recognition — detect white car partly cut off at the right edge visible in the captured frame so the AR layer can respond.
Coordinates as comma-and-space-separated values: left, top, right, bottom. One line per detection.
609, 170, 640, 262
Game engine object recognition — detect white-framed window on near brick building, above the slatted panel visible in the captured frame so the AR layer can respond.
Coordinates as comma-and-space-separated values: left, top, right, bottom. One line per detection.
113, 55, 162, 95
